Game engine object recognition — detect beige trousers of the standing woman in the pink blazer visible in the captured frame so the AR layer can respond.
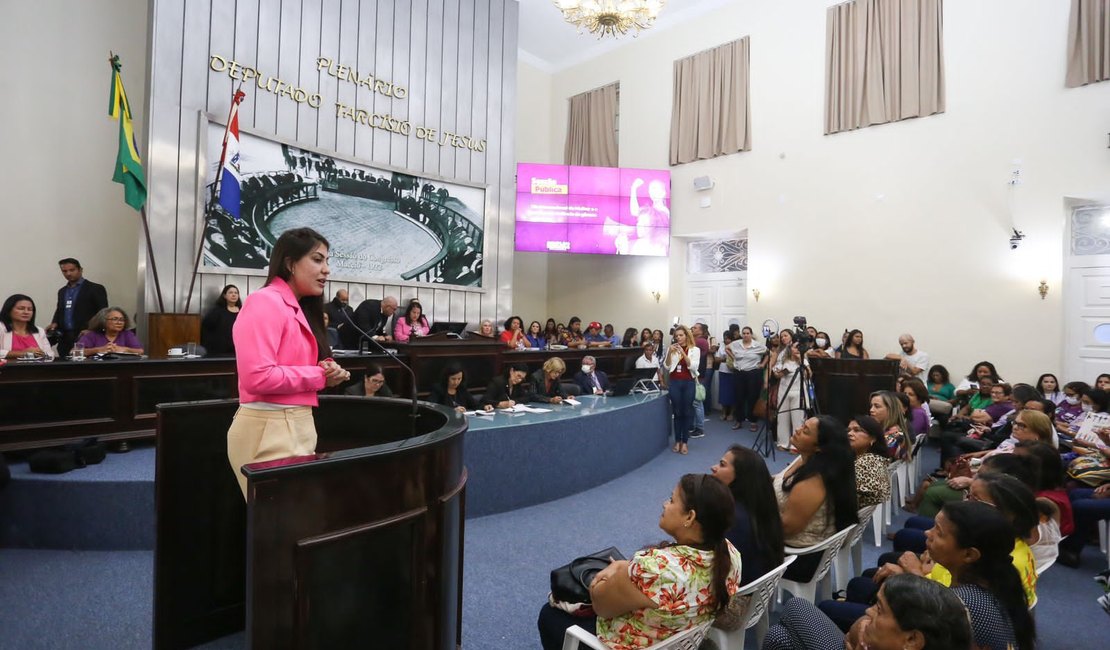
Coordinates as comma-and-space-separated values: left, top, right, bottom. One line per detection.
228, 406, 316, 499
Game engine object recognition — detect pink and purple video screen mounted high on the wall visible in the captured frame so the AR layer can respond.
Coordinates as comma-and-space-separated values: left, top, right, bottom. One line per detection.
516, 163, 670, 256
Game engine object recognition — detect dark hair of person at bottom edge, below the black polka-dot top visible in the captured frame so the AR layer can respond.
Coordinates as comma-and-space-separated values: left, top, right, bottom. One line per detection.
882, 573, 971, 649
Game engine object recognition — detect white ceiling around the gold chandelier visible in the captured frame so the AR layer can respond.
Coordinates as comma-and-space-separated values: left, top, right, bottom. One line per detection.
517, 0, 739, 72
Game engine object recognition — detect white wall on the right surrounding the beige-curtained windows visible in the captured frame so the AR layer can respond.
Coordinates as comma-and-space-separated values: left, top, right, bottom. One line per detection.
537, 0, 1110, 382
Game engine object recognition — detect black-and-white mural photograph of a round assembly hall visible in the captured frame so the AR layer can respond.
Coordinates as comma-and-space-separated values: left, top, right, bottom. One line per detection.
201, 122, 486, 287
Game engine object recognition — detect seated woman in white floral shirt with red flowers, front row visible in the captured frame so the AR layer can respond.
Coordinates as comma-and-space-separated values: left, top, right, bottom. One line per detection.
537, 474, 741, 650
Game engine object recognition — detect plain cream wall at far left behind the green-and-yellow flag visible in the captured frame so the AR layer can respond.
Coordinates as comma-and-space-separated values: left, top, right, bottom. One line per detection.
0, 0, 147, 325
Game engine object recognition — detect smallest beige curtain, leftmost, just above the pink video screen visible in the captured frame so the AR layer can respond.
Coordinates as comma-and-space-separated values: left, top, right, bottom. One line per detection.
564, 83, 620, 167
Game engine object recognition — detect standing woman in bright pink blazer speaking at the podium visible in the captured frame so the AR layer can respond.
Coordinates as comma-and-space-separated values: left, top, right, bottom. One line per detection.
228, 228, 351, 498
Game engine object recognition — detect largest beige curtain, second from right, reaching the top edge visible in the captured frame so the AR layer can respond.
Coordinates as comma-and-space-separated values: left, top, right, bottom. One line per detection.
825, 0, 945, 134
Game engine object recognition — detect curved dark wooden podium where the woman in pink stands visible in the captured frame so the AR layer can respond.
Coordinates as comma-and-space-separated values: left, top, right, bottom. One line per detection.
154, 396, 466, 650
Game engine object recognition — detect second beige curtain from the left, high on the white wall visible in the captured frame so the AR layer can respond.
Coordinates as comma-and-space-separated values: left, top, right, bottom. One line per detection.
670, 37, 751, 165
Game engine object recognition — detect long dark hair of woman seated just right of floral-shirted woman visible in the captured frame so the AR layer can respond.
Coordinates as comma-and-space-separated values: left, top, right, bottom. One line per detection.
728, 445, 786, 566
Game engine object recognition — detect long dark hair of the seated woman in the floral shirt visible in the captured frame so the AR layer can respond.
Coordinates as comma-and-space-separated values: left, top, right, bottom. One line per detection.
678, 474, 734, 613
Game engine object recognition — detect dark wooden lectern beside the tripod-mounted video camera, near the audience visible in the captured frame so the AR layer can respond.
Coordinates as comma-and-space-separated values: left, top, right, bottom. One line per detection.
809, 358, 898, 425
